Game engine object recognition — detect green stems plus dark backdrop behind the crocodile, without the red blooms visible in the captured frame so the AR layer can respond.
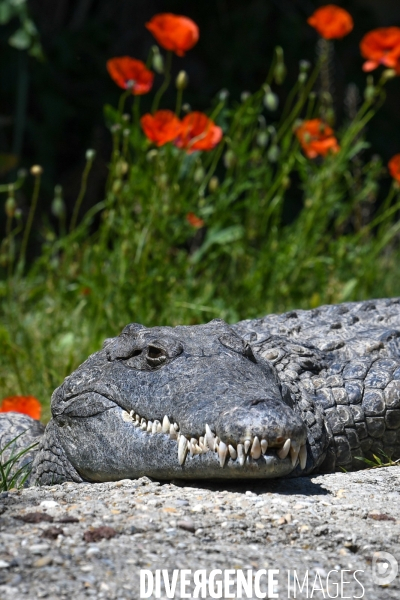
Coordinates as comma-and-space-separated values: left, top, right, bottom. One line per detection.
0, 0, 400, 412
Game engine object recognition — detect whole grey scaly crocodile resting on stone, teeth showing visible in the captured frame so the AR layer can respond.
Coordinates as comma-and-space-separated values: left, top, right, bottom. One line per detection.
0, 298, 400, 485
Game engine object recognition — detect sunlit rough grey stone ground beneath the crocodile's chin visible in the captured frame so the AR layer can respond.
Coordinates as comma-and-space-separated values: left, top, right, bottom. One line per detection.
0, 467, 400, 600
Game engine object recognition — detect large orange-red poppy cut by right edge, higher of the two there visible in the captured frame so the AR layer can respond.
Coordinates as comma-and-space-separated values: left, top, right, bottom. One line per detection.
360, 27, 400, 75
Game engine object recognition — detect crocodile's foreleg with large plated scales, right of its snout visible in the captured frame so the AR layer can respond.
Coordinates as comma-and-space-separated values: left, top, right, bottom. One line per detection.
302, 357, 400, 470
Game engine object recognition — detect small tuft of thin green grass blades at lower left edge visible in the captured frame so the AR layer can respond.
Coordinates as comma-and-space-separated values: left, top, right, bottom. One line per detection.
0, 432, 39, 492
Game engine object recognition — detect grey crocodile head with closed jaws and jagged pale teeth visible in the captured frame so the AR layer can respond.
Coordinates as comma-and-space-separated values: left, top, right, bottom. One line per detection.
43, 320, 307, 481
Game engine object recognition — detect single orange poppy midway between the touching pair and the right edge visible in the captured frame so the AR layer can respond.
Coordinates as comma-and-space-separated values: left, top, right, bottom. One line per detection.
296, 119, 340, 158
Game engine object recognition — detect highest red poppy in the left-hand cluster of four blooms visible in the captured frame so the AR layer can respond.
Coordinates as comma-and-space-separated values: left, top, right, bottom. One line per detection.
146, 13, 199, 56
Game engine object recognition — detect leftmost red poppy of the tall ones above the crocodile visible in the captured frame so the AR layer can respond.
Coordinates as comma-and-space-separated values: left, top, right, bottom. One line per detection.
107, 56, 154, 96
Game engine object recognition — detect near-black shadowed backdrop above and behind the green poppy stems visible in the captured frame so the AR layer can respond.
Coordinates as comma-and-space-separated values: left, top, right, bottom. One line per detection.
0, 0, 400, 221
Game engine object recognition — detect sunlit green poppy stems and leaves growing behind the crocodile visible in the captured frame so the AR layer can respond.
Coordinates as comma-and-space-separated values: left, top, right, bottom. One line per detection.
0, 47, 400, 418
